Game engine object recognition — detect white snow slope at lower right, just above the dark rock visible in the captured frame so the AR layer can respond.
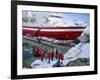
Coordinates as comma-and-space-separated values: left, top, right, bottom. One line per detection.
63, 43, 90, 65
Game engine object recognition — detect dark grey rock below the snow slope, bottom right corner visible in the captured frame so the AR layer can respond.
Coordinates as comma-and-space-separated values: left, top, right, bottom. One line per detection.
66, 58, 89, 66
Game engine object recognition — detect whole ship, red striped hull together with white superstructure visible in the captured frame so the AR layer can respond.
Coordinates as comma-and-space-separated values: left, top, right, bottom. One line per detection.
22, 13, 86, 40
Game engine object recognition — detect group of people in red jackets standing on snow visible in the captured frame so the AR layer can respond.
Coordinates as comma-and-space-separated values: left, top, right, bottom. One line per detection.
33, 47, 64, 64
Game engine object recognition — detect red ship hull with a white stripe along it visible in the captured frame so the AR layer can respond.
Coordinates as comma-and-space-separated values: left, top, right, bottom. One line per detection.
23, 26, 85, 40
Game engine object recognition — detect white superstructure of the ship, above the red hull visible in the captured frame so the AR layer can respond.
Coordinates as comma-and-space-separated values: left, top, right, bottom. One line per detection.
23, 11, 68, 27
